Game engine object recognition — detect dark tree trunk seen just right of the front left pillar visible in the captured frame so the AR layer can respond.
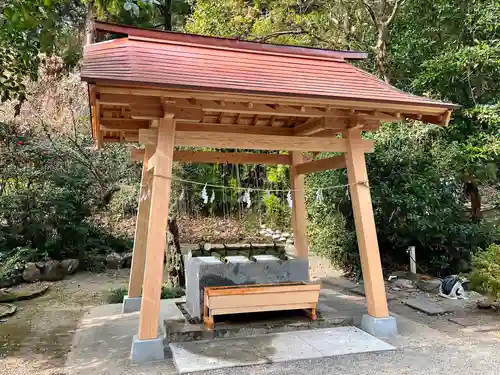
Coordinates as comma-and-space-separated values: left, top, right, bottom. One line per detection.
166, 217, 186, 289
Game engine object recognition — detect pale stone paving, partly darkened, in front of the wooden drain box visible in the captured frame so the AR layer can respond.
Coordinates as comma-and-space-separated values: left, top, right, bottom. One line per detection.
170, 327, 395, 374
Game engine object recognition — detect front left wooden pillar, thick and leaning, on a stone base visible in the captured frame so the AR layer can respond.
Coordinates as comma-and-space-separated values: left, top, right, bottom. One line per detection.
138, 118, 175, 340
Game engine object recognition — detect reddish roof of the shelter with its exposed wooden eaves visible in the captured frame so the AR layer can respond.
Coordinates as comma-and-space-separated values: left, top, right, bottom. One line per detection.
81, 23, 457, 147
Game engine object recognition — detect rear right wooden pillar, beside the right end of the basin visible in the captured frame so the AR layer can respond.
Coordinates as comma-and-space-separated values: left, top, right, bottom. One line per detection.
290, 151, 309, 258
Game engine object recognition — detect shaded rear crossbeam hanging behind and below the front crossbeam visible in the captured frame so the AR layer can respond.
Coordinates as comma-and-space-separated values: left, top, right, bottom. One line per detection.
174, 150, 290, 165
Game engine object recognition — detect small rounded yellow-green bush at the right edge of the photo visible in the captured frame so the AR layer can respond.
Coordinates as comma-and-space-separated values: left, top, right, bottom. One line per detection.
469, 245, 500, 298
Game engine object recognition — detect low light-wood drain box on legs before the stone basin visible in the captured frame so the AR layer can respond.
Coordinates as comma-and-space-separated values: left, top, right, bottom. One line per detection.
203, 282, 320, 329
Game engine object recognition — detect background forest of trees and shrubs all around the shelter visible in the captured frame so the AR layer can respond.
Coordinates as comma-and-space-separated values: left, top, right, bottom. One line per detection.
0, 0, 500, 286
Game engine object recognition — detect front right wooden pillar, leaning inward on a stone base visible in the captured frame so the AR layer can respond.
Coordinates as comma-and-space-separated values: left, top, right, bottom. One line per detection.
345, 128, 389, 318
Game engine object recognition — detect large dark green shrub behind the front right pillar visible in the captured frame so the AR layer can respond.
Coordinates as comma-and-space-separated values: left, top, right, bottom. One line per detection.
307, 124, 500, 274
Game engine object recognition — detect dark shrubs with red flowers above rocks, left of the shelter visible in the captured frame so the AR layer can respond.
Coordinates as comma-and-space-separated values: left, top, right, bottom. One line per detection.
0, 119, 135, 261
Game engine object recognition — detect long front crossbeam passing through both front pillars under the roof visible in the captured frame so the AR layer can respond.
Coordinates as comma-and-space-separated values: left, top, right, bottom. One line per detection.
139, 129, 373, 152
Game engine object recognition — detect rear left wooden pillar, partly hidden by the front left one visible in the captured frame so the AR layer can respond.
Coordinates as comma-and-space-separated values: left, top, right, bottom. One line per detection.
128, 146, 154, 298
